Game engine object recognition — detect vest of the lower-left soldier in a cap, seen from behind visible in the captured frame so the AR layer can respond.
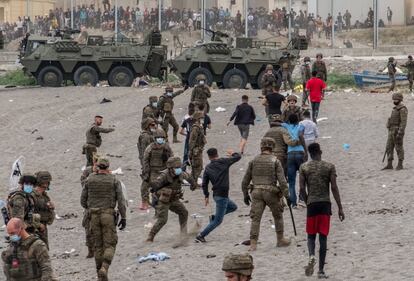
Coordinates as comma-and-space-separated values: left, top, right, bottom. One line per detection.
87, 173, 116, 209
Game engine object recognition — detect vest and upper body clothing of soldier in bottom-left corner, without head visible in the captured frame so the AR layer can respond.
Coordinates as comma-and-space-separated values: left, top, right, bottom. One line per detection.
1, 235, 42, 280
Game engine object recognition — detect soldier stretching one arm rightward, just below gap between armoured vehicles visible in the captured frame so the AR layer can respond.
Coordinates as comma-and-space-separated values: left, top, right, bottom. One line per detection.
158, 86, 188, 143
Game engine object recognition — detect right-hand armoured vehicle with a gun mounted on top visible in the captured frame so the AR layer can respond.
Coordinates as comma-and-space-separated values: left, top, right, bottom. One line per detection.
168, 30, 308, 89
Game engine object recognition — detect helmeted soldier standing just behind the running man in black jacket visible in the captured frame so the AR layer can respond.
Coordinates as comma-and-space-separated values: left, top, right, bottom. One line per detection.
188, 111, 207, 182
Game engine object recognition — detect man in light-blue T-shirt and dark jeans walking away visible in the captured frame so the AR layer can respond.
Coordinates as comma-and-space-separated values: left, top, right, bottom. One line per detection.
283, 114, 308, 208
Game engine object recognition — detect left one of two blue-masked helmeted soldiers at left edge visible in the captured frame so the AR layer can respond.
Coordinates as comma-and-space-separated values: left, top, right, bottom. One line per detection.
7, 174, 40, 234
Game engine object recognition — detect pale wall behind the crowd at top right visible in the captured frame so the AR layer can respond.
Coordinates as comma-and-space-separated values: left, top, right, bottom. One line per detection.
308, 0, 406, 25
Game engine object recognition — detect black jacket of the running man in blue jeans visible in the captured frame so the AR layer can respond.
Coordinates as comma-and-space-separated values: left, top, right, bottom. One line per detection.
201, 153, 241, 198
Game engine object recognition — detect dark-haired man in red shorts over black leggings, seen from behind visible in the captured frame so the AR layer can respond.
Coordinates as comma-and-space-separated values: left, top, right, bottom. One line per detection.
299, 143, 345, 279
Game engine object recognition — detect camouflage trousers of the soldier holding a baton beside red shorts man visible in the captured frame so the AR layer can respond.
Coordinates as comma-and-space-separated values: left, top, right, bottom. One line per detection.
250, 187, 283, 241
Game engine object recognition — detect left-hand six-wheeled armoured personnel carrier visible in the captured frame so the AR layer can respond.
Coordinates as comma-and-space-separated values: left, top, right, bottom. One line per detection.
20, 32, 167, 87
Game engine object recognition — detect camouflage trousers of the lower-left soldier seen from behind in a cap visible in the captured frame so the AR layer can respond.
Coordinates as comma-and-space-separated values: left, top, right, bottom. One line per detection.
90, 208, 118, 270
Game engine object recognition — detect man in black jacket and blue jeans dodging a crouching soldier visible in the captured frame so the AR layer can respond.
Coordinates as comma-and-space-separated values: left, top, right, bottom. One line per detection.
196, 148, 241, 243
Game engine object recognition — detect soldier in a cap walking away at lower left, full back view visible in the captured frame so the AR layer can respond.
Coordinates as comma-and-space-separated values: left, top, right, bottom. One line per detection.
81, 157, 126, 281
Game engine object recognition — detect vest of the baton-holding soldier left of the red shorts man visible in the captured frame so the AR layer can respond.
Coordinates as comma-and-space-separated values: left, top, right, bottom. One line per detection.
252, 155, 277, 185
